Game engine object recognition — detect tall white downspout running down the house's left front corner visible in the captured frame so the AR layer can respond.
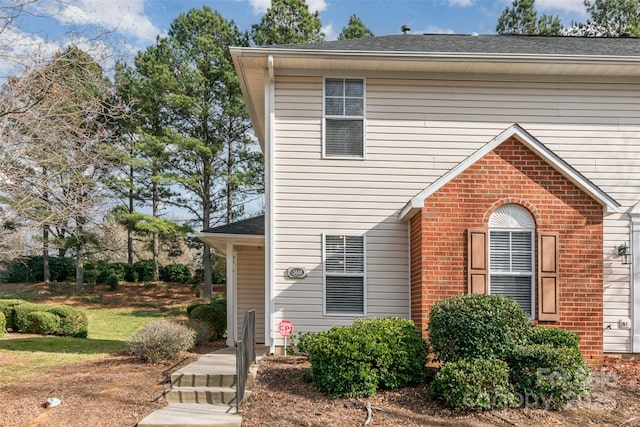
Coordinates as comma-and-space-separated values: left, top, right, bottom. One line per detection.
264, 55, 276, 354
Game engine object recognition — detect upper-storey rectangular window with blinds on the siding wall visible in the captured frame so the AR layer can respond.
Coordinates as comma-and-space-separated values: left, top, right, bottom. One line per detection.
324, 79, 364, 157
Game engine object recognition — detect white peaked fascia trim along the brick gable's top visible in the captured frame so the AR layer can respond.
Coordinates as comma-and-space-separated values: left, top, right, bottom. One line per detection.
399, 124, 620, 221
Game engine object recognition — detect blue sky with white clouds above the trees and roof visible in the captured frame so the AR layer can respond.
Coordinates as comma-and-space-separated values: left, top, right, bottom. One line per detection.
0, 0, 586, 78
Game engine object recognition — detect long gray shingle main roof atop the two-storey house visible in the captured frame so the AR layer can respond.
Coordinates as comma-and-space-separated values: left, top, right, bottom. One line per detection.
272, 34, 640, 57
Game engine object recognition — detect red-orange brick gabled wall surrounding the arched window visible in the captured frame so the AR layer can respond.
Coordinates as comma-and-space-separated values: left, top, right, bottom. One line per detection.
410, 138, 603, 363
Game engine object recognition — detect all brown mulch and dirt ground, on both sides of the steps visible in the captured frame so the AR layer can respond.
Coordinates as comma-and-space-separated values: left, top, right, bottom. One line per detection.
0, 285, 640, 427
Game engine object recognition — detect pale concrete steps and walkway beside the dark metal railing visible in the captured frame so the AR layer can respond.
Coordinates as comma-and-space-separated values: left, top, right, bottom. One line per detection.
138, 347, 268, 427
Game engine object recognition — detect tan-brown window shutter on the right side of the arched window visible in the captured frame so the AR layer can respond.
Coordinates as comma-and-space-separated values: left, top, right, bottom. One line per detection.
538, 232, 560, 321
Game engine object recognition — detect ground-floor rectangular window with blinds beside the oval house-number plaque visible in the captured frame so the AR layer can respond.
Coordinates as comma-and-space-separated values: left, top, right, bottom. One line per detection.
324, 235, 365, 315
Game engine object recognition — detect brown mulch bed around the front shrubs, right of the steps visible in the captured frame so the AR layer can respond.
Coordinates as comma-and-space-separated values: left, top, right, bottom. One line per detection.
241, 356, 640, 427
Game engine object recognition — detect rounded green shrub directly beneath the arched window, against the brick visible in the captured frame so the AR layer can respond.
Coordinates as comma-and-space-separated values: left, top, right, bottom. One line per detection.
428, 294, 531, 362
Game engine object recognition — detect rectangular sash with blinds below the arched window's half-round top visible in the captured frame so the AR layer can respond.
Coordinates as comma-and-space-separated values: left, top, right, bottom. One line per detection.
489, 230, 535, 318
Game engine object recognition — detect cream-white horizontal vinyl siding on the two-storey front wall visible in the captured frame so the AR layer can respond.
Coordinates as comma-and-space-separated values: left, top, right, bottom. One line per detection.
274, 70, 640, 352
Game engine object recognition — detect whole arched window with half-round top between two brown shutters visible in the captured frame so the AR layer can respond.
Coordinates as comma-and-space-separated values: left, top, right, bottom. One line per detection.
489, 204, 536, 318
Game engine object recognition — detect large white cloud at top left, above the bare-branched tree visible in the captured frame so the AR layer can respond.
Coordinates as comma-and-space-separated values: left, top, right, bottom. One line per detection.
45, 0, 160, 41
